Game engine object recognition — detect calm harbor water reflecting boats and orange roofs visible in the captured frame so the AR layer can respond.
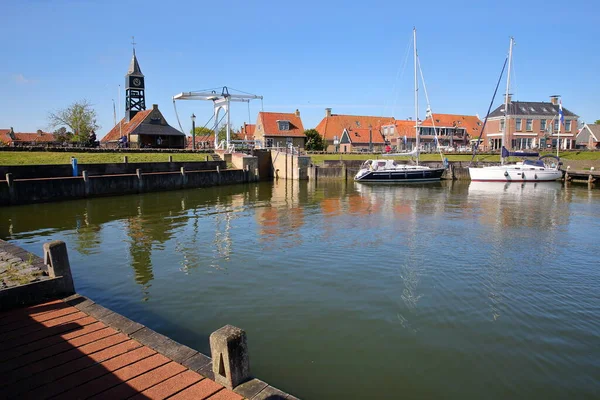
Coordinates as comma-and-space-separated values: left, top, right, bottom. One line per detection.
0, 181, 600, 399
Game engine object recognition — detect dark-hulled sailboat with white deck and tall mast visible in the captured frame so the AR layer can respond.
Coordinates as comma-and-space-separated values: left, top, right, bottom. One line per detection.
354, 29, 445, 183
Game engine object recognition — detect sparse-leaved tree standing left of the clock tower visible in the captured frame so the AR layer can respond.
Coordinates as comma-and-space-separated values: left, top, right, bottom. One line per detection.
48, 100, 100, 142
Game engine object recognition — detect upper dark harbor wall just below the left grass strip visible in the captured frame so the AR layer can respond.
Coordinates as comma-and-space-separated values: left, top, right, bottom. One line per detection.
0, 161, 227, 179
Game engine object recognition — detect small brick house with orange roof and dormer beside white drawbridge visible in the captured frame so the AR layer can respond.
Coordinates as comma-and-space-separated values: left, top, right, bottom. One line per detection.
254, 110, 306, 149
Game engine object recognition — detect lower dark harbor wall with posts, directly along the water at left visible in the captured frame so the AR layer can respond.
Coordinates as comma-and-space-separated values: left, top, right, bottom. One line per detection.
0, 168, 258, 206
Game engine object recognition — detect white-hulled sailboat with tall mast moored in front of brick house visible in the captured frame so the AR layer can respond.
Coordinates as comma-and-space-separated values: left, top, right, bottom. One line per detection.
469, 37, 562, 182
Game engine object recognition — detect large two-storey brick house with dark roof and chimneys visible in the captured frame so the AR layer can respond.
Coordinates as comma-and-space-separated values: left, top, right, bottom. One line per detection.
481, 96, 579, 150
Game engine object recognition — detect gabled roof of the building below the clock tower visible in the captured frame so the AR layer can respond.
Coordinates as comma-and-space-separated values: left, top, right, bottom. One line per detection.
101, 104, 185, 143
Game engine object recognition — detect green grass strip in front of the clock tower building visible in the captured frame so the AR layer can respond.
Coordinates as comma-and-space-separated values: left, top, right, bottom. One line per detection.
0, 151, 212, 165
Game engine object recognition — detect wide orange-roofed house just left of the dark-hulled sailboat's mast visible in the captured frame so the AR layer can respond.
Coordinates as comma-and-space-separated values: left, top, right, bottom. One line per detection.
315, 108, 395, 153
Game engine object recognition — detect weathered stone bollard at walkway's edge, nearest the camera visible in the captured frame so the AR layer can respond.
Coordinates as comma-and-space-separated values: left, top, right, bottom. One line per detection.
210, 325, 250, 389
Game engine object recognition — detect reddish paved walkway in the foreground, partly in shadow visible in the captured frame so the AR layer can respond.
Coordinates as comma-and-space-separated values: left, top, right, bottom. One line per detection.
0, 300, 243, 400
